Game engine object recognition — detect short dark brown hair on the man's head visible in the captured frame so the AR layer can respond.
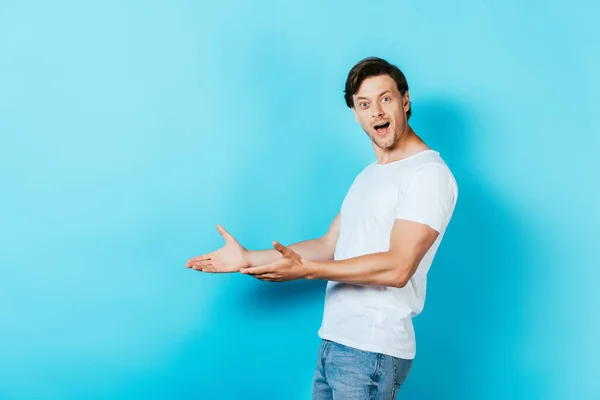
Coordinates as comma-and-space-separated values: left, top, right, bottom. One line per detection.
344, 57, 412, 119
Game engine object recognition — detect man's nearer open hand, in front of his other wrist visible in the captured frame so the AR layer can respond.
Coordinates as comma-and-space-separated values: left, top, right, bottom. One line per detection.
240, 242, 308, 282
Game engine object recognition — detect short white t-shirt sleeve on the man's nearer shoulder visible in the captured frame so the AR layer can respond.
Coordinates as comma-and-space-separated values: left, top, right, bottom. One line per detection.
396, 164, 458, 233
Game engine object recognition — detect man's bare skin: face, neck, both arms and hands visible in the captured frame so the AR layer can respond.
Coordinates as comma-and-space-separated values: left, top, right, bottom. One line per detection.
186, 75, 438, 288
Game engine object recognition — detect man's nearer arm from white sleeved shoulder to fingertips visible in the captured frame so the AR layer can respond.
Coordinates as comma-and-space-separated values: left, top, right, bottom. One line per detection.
241, 164, 458, 287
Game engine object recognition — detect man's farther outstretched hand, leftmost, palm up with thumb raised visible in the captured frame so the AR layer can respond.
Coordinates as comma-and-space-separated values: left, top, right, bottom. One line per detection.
186, 225, 250, 273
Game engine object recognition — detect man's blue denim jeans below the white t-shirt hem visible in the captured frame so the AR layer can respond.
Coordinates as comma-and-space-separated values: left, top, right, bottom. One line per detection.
312, 340, 413, 400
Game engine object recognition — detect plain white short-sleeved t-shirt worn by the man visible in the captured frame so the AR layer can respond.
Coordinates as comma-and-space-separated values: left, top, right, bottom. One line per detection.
319, 150, 458, 359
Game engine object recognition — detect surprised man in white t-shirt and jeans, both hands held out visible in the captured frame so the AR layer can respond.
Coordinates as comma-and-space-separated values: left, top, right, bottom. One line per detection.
187, 57, 458, 400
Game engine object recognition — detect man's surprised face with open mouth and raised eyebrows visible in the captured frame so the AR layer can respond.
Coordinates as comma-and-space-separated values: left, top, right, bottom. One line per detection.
352, 75, 410, 150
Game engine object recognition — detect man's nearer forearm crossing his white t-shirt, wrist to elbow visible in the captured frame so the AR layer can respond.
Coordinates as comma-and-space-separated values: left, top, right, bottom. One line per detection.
305, 252, 410, 287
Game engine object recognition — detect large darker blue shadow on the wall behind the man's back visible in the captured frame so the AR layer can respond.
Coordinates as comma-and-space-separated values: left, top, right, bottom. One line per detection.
403, 98, 527, 400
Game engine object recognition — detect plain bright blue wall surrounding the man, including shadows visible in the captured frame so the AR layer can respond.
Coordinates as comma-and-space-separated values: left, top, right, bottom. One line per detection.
0, 0, 600, 400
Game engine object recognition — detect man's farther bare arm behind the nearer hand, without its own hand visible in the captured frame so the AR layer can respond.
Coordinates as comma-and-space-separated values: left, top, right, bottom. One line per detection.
246, 214, 340, 267
